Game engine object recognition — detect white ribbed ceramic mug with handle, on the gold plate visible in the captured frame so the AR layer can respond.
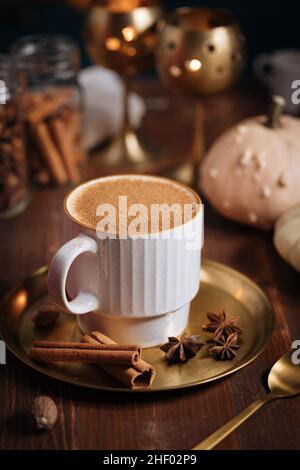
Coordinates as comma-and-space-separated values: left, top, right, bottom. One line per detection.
48, 176, 203, 346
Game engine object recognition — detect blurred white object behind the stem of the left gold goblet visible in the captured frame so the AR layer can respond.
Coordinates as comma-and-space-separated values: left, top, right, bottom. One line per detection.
79, 65, 145, 150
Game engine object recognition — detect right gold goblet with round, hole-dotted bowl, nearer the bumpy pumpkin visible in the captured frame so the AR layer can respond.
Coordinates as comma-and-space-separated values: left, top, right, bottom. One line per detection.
156, 8, 245, 186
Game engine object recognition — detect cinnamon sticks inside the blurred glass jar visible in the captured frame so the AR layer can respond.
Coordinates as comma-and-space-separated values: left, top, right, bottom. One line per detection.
24, 87, 84, 186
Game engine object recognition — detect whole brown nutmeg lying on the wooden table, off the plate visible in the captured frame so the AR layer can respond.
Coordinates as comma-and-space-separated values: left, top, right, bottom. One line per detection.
30, 395, 57, 431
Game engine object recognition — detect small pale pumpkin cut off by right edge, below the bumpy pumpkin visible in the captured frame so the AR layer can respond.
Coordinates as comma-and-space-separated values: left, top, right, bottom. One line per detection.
274, 206, 300, 271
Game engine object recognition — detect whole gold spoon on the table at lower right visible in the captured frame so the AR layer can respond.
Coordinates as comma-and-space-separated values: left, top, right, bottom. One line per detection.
192, 351, 300, 450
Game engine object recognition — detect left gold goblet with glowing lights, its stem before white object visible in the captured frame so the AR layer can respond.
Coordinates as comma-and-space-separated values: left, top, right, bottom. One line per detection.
86, 5, 162, 171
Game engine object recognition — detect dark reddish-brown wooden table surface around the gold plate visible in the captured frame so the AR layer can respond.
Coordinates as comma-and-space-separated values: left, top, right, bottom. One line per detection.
0, 80, 300, 450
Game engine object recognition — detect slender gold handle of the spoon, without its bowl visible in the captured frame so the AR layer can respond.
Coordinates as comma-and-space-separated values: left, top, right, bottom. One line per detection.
192, 394, 274, 450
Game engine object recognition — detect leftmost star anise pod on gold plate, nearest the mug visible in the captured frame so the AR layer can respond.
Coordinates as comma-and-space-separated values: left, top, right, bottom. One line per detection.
160, 333, 203, 362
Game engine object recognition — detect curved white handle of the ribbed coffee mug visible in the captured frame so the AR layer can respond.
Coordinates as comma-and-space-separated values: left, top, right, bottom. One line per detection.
48, 233, 100, 314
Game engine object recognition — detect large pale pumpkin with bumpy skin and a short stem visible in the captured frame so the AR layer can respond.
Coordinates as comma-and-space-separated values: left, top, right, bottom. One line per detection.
200, 97, 300, 229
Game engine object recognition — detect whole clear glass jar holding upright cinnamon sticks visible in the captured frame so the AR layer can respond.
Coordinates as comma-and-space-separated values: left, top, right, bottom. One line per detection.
11, 35, 85, 186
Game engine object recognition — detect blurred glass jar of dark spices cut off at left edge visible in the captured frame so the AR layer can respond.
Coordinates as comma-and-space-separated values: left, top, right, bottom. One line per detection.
0, 54, 28, 218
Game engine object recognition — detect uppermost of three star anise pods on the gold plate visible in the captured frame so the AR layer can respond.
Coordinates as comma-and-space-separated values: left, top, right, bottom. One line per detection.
202, 310, 243, 341
